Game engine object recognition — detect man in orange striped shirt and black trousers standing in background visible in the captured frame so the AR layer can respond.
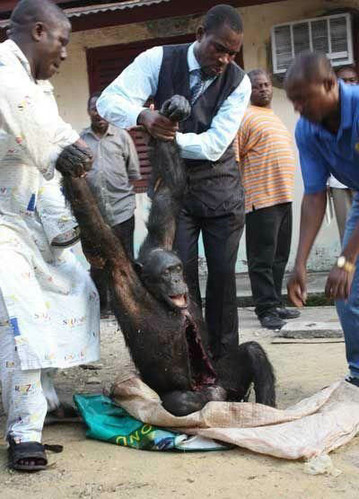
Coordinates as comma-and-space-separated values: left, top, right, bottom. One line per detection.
238, 69, 299, 329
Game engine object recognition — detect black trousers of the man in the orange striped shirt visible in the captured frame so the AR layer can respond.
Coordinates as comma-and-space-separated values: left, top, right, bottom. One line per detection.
246, 203, 292, 317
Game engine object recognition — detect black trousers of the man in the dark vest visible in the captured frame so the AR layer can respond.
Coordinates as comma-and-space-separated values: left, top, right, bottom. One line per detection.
175, 208, 244, 358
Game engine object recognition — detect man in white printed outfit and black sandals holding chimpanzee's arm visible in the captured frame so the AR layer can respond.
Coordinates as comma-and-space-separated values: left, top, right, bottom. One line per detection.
0, 0, 99, 471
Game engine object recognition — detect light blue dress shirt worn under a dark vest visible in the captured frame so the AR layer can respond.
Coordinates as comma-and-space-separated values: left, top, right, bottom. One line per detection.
97, 42, 251, 161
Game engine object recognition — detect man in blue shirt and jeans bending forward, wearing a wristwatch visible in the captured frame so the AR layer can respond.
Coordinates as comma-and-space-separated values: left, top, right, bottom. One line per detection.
285, 53, 359, 386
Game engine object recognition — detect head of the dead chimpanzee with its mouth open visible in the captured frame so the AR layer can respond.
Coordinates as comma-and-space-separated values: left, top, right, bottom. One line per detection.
140, 248, 188, 310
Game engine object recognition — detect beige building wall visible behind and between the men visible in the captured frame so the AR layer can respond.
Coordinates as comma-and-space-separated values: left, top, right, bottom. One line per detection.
53, 0, 359, 272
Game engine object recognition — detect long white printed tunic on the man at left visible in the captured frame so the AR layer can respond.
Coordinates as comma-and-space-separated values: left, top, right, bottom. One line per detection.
0, 40, 100, 369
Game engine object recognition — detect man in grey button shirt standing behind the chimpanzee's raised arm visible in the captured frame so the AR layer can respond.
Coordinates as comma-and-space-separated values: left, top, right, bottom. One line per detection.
81, 94, 141, 314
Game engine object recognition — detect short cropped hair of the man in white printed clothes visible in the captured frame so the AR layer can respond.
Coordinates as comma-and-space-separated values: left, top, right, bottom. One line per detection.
10, 0, 70, 36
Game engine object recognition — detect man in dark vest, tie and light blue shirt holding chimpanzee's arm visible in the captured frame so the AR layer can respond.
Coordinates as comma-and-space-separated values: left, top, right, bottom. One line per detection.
97, 5, 250, 364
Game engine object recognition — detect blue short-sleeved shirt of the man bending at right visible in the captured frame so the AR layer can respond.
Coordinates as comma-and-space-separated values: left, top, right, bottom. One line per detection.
295, 81, 359, 194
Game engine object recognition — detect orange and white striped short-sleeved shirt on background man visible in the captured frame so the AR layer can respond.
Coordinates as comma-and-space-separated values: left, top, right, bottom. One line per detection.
238, 106, 295, 213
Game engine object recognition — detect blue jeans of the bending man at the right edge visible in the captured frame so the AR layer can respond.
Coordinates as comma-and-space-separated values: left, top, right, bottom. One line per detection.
336, 192, 359, 378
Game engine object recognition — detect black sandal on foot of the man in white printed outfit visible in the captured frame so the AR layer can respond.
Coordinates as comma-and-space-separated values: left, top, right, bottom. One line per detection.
8, 438, 63, 472
